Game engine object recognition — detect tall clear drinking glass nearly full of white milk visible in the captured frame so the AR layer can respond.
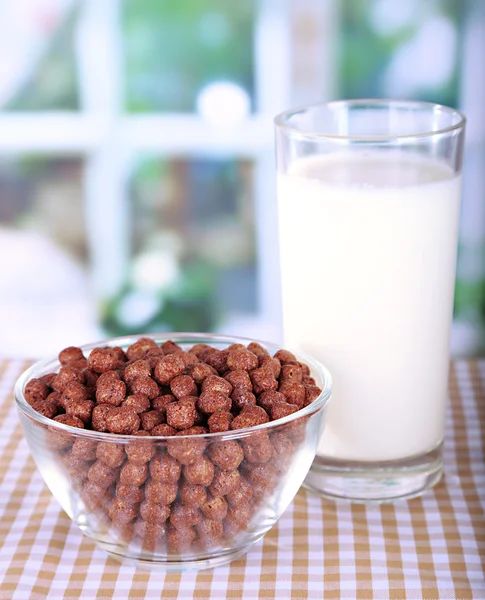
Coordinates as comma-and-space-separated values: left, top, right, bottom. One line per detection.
275, 100, 465, 502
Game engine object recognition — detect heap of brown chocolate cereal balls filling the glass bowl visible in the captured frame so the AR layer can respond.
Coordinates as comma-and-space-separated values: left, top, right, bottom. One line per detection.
24, 338, 321, 553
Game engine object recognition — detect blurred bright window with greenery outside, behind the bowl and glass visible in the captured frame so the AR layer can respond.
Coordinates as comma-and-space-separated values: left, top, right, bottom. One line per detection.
0, 0, 485, 357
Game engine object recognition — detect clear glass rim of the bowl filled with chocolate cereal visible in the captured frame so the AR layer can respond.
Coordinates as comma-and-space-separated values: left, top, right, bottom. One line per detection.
14, 332, 332, 443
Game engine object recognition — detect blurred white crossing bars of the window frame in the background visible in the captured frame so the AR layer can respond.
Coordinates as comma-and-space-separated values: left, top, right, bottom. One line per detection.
0, 0, 338, 332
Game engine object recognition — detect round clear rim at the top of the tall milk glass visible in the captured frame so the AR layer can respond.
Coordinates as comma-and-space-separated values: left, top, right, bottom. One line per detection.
273, 98, 467, 142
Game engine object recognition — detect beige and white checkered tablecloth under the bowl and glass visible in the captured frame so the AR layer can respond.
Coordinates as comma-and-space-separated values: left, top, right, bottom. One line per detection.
0, 361, 485, 600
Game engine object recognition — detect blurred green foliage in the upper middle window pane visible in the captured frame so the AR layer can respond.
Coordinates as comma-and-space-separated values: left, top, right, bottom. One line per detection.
123, 0, 256, 112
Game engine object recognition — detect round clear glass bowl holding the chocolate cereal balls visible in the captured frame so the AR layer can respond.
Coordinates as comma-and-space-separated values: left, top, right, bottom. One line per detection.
15, 333, 331, 570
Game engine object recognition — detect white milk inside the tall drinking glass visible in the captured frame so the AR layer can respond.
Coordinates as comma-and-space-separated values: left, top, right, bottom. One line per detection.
278, 151, 460, 461
